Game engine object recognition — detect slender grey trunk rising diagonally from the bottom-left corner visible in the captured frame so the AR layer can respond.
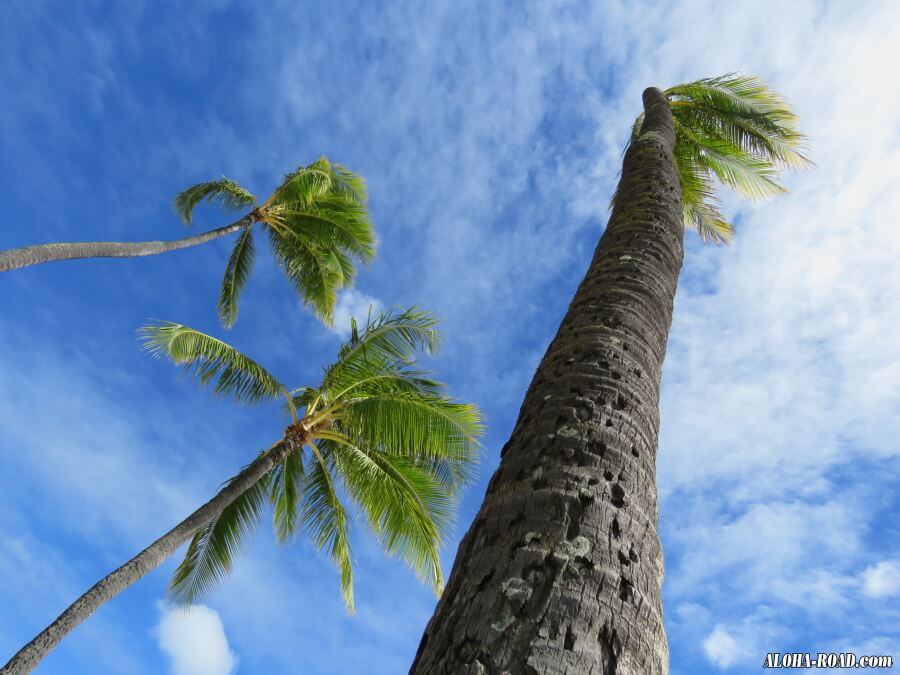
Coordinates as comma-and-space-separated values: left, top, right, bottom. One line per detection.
0, 441, 296, 675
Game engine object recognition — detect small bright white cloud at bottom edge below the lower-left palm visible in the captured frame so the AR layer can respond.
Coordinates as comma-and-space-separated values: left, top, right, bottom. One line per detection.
156, 605, 237, 675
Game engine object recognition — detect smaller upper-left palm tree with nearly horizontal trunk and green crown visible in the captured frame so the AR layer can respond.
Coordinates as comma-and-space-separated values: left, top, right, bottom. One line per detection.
0, 157, 375, 327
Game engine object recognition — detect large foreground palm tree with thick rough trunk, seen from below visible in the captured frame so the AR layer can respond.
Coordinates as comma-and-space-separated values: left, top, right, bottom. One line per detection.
411, 75, 809, 675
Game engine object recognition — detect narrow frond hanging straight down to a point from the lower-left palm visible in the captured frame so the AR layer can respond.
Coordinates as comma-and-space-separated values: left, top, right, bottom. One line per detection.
298, 448, 354, 612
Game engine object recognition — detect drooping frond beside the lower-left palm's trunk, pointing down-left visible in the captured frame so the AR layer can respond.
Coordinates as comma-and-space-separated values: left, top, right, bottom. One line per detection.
169, 474, 269, 605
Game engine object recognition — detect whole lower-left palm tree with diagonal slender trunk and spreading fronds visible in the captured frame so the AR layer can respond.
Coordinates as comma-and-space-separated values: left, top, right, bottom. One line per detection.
0, 309, 482, 675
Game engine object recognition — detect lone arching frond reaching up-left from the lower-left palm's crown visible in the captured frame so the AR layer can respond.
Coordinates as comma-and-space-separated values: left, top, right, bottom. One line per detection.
138, 321, 287, 403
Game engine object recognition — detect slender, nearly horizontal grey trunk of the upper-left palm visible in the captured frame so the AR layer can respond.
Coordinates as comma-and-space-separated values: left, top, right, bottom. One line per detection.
0, 215, 253, 272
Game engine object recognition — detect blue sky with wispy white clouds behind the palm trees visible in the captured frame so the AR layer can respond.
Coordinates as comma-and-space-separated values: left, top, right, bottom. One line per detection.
0, 0, 900, 675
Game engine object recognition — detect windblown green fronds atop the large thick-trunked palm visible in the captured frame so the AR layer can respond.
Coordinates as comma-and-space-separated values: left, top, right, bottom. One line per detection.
613, 73, 812, 243
